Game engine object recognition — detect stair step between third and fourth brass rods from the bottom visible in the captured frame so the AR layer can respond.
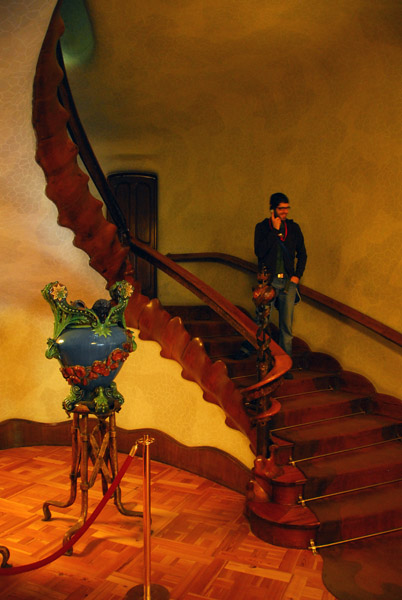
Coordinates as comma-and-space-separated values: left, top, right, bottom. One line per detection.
271, 414, 399, 461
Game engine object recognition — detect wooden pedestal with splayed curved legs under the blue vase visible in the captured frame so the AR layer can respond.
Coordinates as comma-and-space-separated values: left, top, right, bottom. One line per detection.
42, 404, 142, 554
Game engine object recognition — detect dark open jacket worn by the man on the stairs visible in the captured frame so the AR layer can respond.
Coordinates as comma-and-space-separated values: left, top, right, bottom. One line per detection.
254, 219, 307, 278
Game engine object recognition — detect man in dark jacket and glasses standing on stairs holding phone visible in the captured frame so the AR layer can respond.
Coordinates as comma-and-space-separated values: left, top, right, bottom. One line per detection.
254, 192, 307, 379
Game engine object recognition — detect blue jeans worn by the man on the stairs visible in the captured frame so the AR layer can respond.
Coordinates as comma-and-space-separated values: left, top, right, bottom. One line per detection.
271, 277, 297, 356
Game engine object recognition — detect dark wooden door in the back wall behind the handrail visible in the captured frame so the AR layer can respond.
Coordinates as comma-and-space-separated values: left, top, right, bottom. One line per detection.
107, 173, 158, 298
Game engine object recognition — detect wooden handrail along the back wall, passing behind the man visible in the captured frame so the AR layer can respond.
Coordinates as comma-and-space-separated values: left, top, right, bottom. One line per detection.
167, 252, 402, 347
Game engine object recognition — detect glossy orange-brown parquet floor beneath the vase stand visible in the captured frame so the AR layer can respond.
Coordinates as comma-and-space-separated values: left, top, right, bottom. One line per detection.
0, 446, 334, 600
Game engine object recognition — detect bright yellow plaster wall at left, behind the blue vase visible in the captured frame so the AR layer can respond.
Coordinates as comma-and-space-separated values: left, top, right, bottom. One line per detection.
0, 0, 253, 466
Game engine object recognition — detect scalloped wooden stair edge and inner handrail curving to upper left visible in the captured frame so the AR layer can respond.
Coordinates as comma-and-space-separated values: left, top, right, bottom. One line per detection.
32, 0, 291, 460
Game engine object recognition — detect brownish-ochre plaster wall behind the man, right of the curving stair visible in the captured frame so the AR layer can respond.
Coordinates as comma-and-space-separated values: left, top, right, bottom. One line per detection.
63, 0, 402, 396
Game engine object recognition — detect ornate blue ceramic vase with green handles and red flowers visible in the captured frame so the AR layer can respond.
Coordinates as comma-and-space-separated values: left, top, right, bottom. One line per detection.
42, 281, 136, 415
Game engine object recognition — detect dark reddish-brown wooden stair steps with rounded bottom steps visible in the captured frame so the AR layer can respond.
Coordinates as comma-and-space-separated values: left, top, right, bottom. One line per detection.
167, 307, 402, 549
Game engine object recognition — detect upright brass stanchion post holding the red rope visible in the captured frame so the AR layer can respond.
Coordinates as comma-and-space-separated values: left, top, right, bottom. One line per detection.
125, 433, 170, 600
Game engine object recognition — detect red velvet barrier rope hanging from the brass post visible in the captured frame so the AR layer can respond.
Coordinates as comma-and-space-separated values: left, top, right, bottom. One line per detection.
0, 454, 138, 577
